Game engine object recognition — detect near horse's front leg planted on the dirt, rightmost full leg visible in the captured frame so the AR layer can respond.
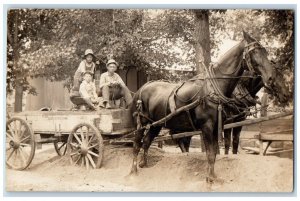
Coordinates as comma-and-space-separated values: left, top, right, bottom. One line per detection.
202, 119, 218, 183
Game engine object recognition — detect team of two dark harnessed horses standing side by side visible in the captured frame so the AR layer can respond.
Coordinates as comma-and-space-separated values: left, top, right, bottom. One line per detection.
130, 32, 287, 183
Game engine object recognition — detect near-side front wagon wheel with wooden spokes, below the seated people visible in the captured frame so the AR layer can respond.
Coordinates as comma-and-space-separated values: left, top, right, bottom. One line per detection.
68, 123, 103, 169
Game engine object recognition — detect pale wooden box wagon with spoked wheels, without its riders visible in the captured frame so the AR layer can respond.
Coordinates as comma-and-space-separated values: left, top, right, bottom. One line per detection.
6, 109, 133, 170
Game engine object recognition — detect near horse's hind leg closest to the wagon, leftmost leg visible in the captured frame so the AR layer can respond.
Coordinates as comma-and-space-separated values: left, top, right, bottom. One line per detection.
130, 129, 145, 174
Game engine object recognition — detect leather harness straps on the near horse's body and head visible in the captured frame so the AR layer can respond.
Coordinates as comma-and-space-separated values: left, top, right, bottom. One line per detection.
133, 41, 263, 142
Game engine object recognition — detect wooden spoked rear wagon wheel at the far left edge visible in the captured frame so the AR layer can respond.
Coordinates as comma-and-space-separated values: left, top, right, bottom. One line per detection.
6, 117, 35, 170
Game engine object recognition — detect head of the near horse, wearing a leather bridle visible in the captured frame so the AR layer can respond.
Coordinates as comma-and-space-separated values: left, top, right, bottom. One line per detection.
243, 31, 276, 88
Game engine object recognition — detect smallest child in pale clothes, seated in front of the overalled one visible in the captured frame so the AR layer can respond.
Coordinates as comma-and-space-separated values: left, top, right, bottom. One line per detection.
79, 71, 99, 110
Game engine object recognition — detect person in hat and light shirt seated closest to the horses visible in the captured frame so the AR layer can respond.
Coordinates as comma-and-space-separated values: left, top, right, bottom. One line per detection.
99, 59, 132, 109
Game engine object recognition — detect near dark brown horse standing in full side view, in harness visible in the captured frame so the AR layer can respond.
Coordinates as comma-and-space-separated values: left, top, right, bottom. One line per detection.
131, 32, 275, 182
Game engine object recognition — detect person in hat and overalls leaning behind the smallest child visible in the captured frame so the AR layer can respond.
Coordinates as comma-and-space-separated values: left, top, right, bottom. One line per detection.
73, 49, 95, 91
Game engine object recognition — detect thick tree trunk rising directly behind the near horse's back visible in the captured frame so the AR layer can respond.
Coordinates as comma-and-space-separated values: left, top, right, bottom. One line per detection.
193, 10, 211, 75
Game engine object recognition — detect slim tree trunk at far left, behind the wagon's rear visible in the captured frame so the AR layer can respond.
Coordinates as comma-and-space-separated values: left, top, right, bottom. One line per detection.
12, 10, 23, 112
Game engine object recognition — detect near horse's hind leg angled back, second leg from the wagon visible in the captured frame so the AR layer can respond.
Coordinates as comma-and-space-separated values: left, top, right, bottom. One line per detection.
139, 127, 161, 168
